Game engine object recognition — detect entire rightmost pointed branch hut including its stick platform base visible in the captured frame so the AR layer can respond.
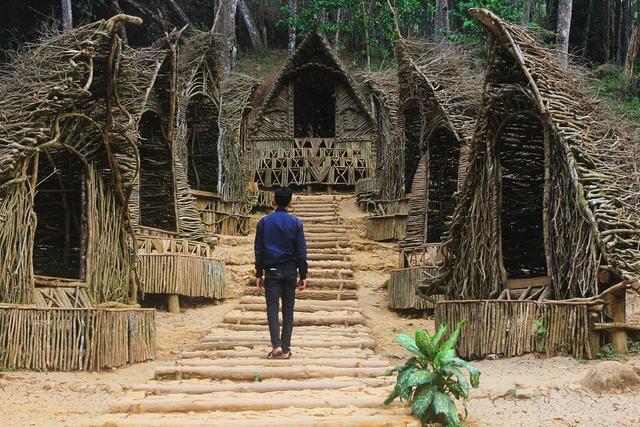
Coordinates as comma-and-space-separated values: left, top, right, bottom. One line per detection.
423, 9, 640, 357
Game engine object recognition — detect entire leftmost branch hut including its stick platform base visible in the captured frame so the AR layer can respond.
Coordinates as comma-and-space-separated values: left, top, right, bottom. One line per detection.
0, 15, 158, 370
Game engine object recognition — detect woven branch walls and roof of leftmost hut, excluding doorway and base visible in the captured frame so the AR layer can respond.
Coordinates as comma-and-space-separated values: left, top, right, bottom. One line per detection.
0, 16, 159, 304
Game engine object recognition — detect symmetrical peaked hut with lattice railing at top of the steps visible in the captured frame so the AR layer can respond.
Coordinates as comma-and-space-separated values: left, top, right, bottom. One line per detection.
249, 32, 375, 193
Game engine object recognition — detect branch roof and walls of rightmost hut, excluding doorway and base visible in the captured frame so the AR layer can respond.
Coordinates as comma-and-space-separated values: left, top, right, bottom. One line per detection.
429, 9, 640, 299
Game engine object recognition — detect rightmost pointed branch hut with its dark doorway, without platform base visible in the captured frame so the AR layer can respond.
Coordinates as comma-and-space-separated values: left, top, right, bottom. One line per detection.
429, 9, 640, 299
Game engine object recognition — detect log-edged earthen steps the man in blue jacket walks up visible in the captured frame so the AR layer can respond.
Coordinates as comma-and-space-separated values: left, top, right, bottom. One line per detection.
96, 195, 420, 427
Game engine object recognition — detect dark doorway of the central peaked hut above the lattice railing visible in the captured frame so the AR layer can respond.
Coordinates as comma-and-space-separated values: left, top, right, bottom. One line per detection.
293, 69, 336, 138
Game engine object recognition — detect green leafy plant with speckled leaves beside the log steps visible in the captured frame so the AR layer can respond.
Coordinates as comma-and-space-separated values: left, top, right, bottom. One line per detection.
385, 320, 480, 426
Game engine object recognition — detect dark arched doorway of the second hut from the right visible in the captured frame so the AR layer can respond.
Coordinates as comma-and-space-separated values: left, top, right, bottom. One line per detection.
426, 127, 460, 243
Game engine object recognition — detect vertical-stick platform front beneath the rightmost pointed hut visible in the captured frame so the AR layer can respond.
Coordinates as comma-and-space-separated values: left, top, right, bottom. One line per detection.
435, 300, 599, 359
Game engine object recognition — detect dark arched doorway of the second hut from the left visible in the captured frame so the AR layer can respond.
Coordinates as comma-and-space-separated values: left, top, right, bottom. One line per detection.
140, 112, 177, 231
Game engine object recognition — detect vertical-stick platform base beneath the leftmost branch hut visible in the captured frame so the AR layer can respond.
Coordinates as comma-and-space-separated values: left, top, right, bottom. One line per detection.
0, 305, 156, 371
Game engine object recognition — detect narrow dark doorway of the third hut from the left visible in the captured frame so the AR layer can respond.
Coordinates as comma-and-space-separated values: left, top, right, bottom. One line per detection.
187, 95, 219, 192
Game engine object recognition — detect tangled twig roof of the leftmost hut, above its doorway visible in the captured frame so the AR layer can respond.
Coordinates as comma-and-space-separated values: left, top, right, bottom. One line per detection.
0, 15, 159, 195
